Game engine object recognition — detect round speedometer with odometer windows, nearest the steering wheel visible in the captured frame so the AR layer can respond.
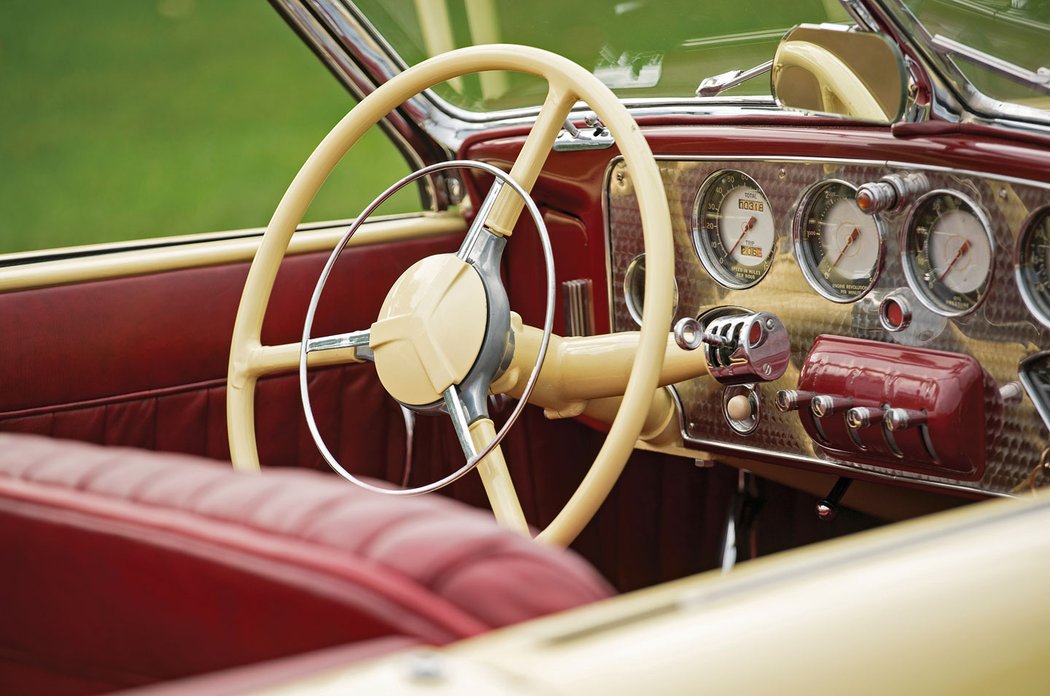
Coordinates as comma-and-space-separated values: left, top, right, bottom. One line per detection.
693, 169, 776, 289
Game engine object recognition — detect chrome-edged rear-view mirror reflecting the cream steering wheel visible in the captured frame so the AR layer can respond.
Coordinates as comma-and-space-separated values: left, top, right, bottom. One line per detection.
770, 24, 907, 123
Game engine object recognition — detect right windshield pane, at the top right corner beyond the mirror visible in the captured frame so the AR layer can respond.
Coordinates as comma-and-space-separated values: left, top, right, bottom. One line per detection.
905, 0, 1050, 117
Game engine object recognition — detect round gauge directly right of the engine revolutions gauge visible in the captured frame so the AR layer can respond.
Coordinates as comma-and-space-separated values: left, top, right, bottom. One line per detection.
901, 191, 995, 317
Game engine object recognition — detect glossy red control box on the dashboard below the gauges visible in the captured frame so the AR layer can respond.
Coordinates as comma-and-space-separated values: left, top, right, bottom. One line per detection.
798, 336, 1002, 481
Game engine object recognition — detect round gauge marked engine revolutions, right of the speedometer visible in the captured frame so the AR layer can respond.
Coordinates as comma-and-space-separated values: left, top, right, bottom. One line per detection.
793, 181, 885, 302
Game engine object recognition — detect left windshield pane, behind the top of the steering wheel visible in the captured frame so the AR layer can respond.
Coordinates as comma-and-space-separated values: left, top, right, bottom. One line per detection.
356, 0, 847, 111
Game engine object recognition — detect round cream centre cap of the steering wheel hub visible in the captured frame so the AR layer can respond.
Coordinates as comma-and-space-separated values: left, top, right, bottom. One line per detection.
370, 254, 488, 406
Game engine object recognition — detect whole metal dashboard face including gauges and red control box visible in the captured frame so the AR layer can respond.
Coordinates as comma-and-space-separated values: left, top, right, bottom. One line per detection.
604, 155, 1050, 494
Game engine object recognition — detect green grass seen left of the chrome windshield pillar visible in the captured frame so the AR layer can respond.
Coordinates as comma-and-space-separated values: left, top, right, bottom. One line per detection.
0, 0, 419, 253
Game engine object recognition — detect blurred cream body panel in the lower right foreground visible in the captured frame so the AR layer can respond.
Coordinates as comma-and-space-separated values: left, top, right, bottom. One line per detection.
256, 499, 1050, 695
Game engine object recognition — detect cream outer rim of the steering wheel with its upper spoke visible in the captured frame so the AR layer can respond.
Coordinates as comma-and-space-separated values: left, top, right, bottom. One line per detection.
227, 44, 674, 545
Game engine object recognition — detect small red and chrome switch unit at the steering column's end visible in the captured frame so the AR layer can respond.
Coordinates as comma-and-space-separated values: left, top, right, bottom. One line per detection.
674, 310, 791, 384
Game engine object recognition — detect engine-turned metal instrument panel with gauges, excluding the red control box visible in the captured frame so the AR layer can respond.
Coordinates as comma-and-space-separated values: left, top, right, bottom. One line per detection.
606, 157, 1050, 494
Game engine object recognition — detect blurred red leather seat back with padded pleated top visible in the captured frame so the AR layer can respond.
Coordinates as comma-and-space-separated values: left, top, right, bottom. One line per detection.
0, 435, 611, 694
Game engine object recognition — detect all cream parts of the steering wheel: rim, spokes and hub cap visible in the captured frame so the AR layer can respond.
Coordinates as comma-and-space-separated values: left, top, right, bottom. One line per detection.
227, 45, 674, 545
